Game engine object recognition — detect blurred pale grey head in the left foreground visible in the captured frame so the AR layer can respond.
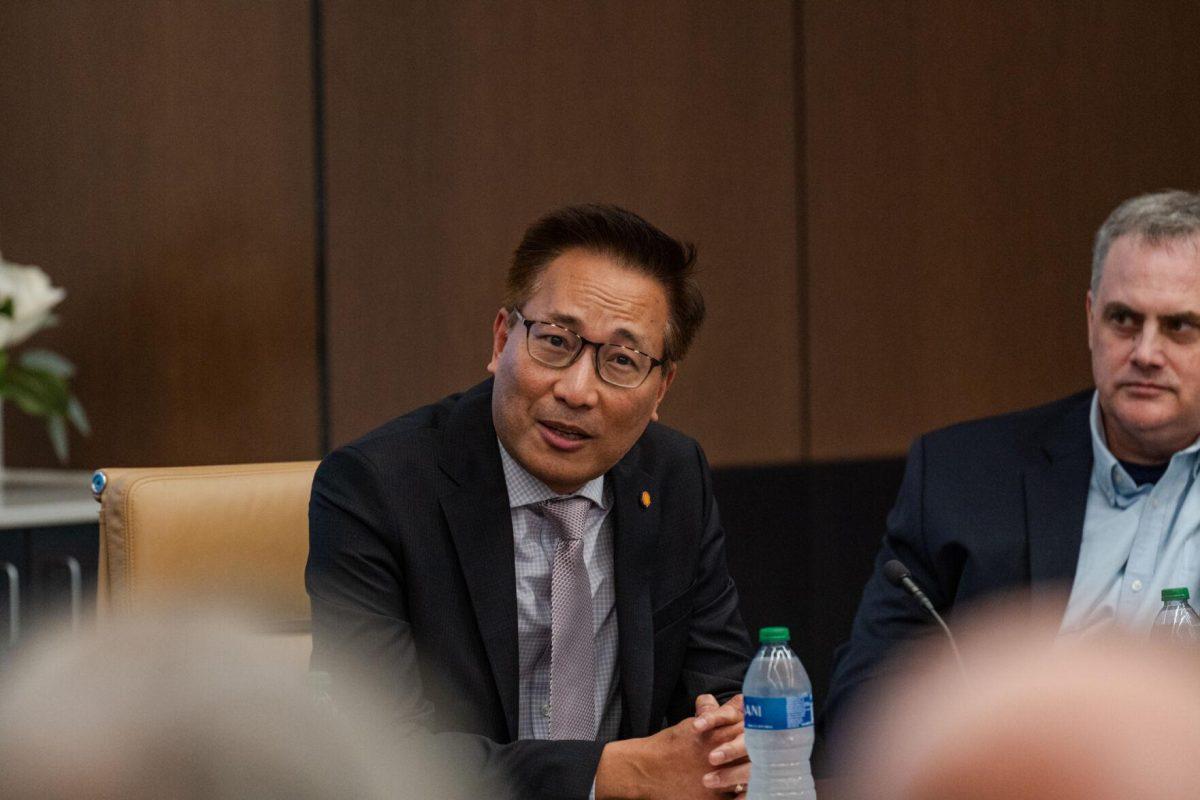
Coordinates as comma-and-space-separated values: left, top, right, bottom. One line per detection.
0, 619, 446, 800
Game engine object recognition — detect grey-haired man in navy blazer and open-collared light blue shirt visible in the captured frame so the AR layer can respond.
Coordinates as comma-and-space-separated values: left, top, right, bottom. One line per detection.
822, 192, 1200, 754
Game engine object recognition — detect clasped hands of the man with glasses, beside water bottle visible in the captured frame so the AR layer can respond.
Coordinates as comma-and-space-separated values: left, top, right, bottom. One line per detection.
595, 694, 750, 800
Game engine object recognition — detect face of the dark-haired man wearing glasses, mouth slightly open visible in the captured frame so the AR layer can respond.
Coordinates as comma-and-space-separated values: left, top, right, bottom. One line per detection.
487, 249, 674, 494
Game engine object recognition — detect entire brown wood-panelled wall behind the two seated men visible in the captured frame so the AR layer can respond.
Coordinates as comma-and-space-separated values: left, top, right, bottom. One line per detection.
0, 0, 1200, 467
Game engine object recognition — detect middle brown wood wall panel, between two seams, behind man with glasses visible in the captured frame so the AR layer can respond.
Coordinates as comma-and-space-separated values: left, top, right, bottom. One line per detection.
325, 0, 802, 463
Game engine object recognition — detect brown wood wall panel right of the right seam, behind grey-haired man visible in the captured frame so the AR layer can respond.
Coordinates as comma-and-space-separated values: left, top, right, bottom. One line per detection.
803, 0, 1200, 459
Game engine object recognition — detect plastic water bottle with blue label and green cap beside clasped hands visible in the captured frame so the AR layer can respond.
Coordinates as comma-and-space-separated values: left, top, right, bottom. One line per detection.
742, 627, 817, 800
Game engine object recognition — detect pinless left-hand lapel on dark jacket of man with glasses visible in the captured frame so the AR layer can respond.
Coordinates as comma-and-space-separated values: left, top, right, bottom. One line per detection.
439, 381, 520, 740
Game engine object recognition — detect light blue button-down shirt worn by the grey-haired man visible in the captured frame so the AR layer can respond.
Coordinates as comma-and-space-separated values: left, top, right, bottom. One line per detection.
1060, 395, 1200, 636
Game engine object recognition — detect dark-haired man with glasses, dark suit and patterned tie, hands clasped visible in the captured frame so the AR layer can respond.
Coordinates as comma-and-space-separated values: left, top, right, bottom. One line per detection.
306, 206, 750, 798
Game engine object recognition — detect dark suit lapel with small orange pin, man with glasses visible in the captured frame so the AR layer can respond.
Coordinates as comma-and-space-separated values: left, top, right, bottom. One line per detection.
611, 445, 661, 736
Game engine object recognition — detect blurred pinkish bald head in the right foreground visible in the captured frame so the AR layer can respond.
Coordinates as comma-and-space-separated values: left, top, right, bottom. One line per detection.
845, 606, 1200, 800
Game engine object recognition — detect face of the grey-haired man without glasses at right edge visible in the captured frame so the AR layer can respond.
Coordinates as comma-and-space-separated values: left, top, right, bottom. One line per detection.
1087, 235, 1200, 463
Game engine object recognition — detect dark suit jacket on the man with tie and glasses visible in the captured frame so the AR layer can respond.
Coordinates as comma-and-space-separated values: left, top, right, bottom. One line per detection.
305, 380, 751, 798
